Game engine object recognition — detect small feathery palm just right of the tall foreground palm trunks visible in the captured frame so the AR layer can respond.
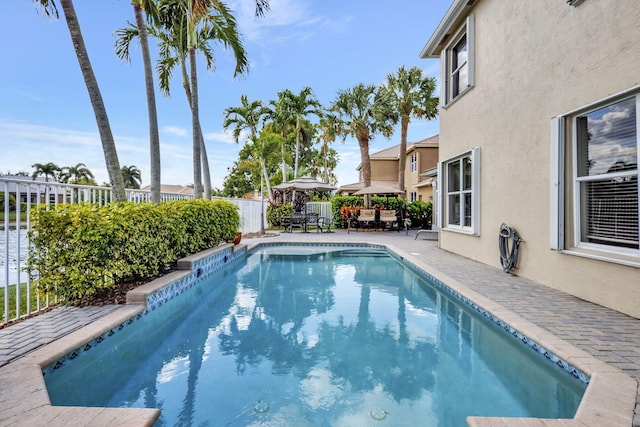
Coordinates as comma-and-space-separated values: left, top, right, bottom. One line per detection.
222, 95, 273, 201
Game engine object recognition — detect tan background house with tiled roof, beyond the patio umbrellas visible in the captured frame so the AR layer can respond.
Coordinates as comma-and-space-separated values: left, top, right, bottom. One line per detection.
337, 135, 438, 202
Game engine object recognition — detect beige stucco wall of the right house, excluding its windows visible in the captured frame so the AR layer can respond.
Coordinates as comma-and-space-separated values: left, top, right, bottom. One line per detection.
422, 0, 640, 318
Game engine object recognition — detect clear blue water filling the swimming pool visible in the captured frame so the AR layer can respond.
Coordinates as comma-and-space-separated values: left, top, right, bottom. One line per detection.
45, 247, 586, 427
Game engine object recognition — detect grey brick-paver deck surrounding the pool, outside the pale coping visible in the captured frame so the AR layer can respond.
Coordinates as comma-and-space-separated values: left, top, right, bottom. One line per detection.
0, 230, 640, 427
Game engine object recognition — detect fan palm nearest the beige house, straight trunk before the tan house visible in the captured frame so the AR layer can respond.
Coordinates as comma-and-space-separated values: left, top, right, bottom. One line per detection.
387, 66, 438, 197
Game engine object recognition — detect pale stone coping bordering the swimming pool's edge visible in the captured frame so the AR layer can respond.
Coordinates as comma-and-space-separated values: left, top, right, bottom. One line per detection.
0, 242, 638, 427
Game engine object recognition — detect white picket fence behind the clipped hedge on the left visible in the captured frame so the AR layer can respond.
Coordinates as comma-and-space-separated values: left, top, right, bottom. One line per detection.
0, 177, 267, 325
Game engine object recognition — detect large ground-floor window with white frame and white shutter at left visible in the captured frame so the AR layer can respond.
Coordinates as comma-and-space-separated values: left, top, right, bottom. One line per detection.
551, 89, 640, 256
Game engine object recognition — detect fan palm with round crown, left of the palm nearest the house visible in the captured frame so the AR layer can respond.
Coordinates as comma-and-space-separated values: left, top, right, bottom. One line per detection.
330, 83, 398, 192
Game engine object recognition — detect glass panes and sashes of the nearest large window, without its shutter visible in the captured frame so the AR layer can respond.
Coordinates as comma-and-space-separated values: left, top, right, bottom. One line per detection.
574, 96, 639, 249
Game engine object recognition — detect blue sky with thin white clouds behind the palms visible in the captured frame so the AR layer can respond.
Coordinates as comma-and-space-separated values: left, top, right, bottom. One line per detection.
0, 0, 451, 189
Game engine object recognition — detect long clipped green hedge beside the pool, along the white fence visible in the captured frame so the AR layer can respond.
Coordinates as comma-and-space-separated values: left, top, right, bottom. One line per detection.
27, 200, 240, 301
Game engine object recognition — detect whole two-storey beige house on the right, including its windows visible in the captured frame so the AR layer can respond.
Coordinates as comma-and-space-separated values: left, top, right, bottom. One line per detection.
420, 0, 640, 318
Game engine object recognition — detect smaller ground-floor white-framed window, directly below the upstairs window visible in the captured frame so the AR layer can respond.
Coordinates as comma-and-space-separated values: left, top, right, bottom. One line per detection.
439, 148, 480, 235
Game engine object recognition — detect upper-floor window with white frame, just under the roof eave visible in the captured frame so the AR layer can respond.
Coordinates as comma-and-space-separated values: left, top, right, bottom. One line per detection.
440, 16, 474, 106
